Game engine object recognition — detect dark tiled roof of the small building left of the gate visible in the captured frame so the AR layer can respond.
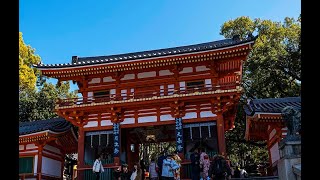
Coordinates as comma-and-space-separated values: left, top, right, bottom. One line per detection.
19, 118, 71, 135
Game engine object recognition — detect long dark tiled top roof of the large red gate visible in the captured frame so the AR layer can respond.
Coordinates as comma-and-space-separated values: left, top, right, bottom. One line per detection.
34, 36, 257, 69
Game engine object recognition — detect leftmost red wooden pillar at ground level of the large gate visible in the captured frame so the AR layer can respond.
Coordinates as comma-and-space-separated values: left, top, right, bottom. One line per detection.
77, 126, 84, 180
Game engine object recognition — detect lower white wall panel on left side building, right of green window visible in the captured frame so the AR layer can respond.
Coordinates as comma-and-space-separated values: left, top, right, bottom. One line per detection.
41, 156, 61, 177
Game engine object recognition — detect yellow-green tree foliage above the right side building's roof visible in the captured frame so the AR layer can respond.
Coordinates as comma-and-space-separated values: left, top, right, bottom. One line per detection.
220, 17, 301, 98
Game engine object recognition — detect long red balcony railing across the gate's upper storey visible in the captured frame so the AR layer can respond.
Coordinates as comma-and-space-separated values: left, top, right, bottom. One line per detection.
57, 82, 239, 107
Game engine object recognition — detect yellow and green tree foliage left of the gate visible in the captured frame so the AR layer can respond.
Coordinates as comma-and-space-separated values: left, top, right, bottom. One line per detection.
19, 32, 76, 122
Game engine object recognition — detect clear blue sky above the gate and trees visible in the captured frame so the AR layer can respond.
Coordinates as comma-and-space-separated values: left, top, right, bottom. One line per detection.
19, 0, 301, 89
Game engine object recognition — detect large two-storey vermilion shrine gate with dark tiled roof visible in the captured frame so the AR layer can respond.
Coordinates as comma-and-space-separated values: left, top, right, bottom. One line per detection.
36, 36, 255, 179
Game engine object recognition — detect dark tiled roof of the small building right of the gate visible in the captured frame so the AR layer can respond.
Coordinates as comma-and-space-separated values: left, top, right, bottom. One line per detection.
244, 97, 301, 116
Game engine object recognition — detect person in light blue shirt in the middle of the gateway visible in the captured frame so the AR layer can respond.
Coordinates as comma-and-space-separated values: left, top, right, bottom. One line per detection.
161, 154, 180, 180
